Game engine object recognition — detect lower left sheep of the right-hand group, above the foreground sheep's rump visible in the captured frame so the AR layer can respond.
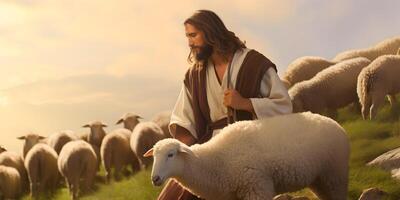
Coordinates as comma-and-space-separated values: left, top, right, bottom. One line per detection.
289, 58, 370, 117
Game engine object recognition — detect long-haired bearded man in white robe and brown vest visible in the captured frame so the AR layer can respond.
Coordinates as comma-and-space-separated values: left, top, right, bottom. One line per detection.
158, 10, 292, 200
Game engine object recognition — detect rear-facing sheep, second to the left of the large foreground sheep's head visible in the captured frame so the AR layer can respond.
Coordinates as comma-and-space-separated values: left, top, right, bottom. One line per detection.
100, 128, 140, 182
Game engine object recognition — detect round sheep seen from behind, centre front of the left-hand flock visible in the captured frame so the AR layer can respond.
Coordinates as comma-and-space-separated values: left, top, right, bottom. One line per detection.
58, 140, 98, 199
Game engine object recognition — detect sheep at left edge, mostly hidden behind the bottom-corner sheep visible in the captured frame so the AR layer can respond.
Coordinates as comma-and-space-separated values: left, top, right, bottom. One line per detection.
0, 151, 29, 191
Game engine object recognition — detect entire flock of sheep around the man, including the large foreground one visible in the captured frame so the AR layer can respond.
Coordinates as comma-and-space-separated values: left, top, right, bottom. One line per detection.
0, 37, 400, 200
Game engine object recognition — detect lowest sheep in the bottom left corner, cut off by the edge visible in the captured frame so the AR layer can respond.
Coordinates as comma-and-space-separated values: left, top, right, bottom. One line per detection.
0, 165, 21, 199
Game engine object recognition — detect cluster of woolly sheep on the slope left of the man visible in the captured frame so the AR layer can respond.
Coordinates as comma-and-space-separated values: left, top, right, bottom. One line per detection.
0, 111, 170, 199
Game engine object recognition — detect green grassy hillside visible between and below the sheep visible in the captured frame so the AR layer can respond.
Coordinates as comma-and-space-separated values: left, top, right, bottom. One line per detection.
19, 96, 400, 200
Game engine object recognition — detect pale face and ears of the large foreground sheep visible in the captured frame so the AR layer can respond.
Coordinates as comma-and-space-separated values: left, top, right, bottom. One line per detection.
143, 138, 194, 186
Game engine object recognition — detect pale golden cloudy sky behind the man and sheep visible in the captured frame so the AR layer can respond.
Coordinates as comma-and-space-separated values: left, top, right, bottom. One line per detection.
0, 0, 400, 151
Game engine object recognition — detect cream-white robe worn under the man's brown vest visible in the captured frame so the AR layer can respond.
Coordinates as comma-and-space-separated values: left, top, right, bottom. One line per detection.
169, 49, 292, 139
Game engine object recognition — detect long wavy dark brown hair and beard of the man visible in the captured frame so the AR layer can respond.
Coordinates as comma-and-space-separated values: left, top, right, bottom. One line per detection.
184, 10, 246, 64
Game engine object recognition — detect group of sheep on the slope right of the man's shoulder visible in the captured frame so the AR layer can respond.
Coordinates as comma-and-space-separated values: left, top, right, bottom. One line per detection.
282, 37, 400, 119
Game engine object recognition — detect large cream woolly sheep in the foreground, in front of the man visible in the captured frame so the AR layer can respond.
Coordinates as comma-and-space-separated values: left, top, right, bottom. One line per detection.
145, 112, 350, 200
